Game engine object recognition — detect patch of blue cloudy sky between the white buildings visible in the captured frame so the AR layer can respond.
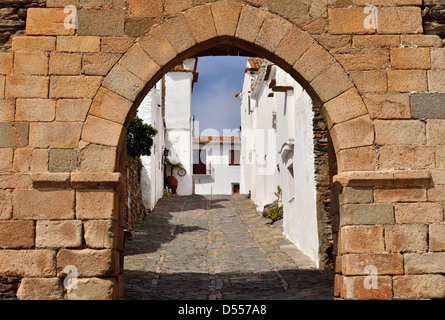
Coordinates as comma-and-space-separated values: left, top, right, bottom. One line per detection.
192, 56, 247, 136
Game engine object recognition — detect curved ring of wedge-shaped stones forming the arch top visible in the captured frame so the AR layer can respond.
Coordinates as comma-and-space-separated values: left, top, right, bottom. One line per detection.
80, 0, 377, 172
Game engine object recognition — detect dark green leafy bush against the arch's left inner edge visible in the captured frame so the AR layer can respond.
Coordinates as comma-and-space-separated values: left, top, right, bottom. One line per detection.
126, 115, 158, 158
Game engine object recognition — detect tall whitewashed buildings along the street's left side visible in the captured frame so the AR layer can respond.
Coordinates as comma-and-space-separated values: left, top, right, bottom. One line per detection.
138, 59, 196, 209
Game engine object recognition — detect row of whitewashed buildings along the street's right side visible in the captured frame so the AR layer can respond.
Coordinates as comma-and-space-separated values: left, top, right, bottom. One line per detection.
237, 58, 319, 266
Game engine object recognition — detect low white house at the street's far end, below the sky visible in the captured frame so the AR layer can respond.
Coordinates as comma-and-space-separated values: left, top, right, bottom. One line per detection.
193, 136, 241, 195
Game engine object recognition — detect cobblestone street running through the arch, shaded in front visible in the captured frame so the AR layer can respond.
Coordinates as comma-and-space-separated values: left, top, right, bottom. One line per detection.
124, 195, 333, 300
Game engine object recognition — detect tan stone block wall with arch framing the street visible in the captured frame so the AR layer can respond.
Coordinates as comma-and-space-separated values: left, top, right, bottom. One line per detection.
0, 0, 445, 299
